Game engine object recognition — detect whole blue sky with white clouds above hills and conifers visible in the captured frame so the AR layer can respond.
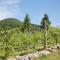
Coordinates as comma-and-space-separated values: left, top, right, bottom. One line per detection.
0, 0, 60, 27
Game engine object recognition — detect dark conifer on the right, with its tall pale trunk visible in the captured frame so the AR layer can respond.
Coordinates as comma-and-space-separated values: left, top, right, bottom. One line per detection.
41, 14, 51, 49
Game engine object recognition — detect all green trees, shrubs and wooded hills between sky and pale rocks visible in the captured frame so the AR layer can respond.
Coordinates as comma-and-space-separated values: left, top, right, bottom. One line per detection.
0, 15, 60, 59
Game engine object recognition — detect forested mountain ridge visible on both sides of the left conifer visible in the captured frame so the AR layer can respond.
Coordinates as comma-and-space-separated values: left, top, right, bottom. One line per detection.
0, 18, 40, 31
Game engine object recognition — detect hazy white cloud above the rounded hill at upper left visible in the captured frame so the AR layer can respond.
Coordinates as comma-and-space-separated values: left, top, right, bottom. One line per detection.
0, 0, 21, 20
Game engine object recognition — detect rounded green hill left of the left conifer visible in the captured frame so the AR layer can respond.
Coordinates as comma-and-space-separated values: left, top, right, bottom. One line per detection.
0, 18, 21, 29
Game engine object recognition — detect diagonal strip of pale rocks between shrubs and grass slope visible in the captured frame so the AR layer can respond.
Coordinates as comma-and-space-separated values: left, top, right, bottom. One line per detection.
7, 45, 60, 60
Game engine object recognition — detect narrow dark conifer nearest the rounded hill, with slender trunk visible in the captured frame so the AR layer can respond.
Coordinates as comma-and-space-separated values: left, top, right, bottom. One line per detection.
23, 14, 30, 49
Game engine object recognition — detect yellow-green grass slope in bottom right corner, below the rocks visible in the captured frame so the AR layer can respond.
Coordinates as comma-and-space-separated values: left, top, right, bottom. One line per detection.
34, 51, 60, 60
